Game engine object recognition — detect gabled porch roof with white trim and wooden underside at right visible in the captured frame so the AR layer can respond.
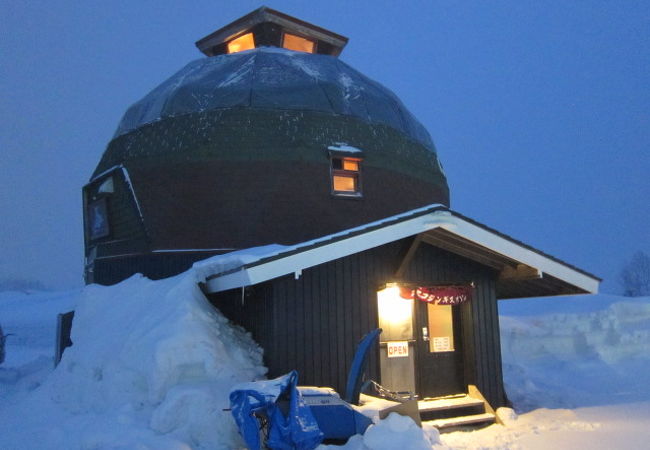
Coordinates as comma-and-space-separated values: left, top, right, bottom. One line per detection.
200, 204, 601, 299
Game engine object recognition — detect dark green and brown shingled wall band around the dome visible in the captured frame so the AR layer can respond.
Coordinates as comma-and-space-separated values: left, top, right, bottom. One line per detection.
95, 108, 449, 256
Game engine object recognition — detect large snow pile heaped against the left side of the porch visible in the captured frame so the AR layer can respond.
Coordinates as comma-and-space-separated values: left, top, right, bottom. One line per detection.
0, 272, 266, 448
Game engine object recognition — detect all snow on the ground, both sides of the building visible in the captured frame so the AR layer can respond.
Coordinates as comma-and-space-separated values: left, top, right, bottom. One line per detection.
0, 274, 650, 449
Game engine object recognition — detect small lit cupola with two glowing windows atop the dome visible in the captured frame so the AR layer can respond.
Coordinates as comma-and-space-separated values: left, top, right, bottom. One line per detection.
196, 6, 348, 56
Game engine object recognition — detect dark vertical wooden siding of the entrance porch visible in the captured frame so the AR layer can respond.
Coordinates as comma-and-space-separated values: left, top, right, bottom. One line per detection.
210, 239, 505, 407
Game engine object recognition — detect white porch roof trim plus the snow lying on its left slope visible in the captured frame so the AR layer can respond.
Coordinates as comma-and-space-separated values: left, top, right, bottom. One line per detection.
194, 204, 600, 293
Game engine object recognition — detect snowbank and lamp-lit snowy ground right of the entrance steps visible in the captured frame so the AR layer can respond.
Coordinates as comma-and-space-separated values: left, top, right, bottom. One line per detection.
442, 294, 650, 449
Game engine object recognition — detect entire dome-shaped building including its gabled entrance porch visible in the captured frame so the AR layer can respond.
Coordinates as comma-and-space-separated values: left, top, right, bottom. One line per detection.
71, 8, 600, 428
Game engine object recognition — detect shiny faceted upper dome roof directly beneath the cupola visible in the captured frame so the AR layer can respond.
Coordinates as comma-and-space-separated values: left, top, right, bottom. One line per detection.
114, 47, 434, 151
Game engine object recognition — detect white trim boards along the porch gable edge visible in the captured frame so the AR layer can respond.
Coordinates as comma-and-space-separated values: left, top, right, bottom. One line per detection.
206, 211, 599, 293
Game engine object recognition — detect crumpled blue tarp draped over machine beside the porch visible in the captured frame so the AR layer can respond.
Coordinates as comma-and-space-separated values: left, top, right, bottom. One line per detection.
230, 370, 323, 450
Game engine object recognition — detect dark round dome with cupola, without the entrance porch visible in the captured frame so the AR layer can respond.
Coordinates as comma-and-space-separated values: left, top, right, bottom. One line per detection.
84, 8, 449, 284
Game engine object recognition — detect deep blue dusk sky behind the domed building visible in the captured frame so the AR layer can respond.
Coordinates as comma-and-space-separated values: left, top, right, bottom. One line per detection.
0, 0, 650, 292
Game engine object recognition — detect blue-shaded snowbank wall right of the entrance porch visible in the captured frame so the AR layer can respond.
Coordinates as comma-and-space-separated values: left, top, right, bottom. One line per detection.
500, 295, 650, 411
